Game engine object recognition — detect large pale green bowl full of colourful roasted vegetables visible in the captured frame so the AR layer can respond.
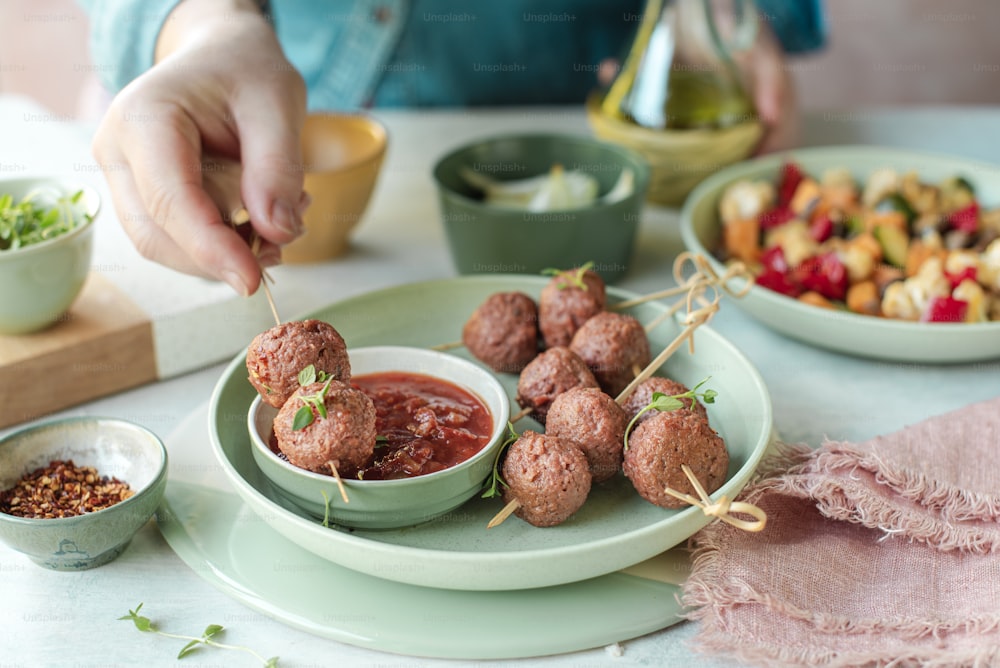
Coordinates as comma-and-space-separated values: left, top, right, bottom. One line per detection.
681, 146, 1000, 363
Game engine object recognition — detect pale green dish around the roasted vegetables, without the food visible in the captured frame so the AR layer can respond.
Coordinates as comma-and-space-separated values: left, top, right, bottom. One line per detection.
681, 146, 1000, 363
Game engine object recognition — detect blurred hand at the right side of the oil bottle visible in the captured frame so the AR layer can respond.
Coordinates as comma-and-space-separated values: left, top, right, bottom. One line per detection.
744, 23, 800, 155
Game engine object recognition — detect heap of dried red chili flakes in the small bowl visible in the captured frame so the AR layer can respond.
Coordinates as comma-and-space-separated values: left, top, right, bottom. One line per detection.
0, 459, 135, 519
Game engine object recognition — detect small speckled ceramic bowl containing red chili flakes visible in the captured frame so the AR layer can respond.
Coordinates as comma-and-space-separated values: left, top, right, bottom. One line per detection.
0, 417, 167, 571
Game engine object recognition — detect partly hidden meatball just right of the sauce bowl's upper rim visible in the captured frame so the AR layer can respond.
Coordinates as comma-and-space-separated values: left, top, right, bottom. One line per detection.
516, 347, 598, 424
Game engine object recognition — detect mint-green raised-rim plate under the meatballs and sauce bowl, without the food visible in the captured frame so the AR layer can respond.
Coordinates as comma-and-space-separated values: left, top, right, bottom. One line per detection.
201, 275, 772, 590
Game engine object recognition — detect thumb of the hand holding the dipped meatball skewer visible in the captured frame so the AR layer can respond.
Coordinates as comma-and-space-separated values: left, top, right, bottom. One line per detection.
236, 87, 307, 244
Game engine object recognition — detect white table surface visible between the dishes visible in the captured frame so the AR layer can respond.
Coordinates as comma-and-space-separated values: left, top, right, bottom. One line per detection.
0, 97, 1000, 668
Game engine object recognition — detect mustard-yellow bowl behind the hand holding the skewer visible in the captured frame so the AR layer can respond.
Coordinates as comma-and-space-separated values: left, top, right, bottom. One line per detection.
281, 113, 388, 264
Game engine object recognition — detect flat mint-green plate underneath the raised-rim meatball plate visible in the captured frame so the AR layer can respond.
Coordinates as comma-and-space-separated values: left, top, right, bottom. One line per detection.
157, 405, 687, 660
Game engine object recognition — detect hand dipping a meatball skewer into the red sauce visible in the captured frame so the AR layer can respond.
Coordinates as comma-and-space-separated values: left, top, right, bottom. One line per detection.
93, 0, 308, 295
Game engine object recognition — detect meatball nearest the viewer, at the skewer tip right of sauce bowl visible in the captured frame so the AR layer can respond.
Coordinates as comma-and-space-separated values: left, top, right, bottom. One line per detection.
502, 430, 590, 527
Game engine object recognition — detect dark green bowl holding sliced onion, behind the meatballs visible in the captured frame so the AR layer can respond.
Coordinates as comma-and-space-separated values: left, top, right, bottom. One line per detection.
434, 134, 649, 282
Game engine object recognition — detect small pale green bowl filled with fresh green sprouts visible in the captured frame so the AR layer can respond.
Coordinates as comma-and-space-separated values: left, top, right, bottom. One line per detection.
0, 178, 100, 334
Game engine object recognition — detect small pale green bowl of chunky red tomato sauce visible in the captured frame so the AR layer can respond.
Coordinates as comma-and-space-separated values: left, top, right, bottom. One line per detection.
248, 346, 510, 529
